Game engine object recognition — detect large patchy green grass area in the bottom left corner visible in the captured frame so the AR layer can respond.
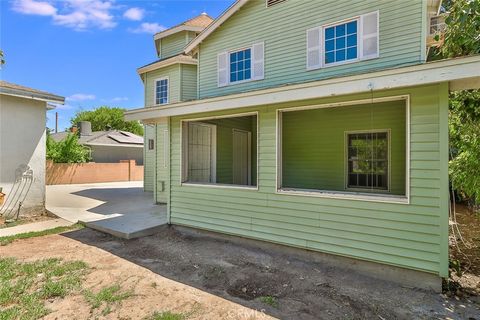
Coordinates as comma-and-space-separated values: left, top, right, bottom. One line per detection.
0, 258, 88, 320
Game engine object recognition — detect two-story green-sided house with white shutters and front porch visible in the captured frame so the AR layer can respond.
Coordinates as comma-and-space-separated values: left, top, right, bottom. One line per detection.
126, 0, 480, 289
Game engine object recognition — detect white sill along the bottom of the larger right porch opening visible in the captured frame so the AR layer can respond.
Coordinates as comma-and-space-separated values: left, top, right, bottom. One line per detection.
277, 188, 410, 204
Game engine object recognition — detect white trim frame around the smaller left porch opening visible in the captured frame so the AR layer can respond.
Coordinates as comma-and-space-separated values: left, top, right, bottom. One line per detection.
179, 111, 260, 191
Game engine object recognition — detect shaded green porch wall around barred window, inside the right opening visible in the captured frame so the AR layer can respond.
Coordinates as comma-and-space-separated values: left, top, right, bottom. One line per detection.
282, 101, 406, 195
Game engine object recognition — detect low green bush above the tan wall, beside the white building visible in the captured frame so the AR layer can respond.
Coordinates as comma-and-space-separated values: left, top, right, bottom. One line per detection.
47, 134, 91, 163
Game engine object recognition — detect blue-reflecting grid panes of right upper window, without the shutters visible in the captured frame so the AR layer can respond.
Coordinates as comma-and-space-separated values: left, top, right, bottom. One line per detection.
324, 20, 358, 65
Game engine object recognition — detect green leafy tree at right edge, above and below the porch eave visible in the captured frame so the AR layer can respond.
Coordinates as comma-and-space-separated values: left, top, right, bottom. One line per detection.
435, 0, 480, 205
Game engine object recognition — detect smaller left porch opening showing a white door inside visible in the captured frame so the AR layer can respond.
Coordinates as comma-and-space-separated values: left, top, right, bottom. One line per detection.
182, 114, 257, 187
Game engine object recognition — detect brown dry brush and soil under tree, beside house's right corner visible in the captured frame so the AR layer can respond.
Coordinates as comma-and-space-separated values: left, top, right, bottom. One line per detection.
450, 204, 480, 296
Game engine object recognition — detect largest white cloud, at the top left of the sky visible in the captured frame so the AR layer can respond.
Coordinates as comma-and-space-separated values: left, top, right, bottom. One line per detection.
12, 0, 117, 31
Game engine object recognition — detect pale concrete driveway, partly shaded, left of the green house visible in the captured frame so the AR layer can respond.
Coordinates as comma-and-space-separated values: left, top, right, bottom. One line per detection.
46, 181, 167, 239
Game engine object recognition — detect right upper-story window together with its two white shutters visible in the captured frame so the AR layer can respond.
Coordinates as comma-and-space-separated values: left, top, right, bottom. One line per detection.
307, 11, 380, 70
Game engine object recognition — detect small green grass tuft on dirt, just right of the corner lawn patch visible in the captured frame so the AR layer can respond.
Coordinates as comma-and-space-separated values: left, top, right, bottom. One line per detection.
84, 284, 133, 316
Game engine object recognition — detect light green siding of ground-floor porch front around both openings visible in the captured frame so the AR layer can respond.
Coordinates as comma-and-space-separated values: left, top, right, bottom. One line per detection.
170, 85, 448, 276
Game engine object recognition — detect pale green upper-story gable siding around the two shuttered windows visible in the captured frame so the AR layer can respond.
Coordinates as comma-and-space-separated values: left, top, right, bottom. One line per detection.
199, 0, 425, 98
